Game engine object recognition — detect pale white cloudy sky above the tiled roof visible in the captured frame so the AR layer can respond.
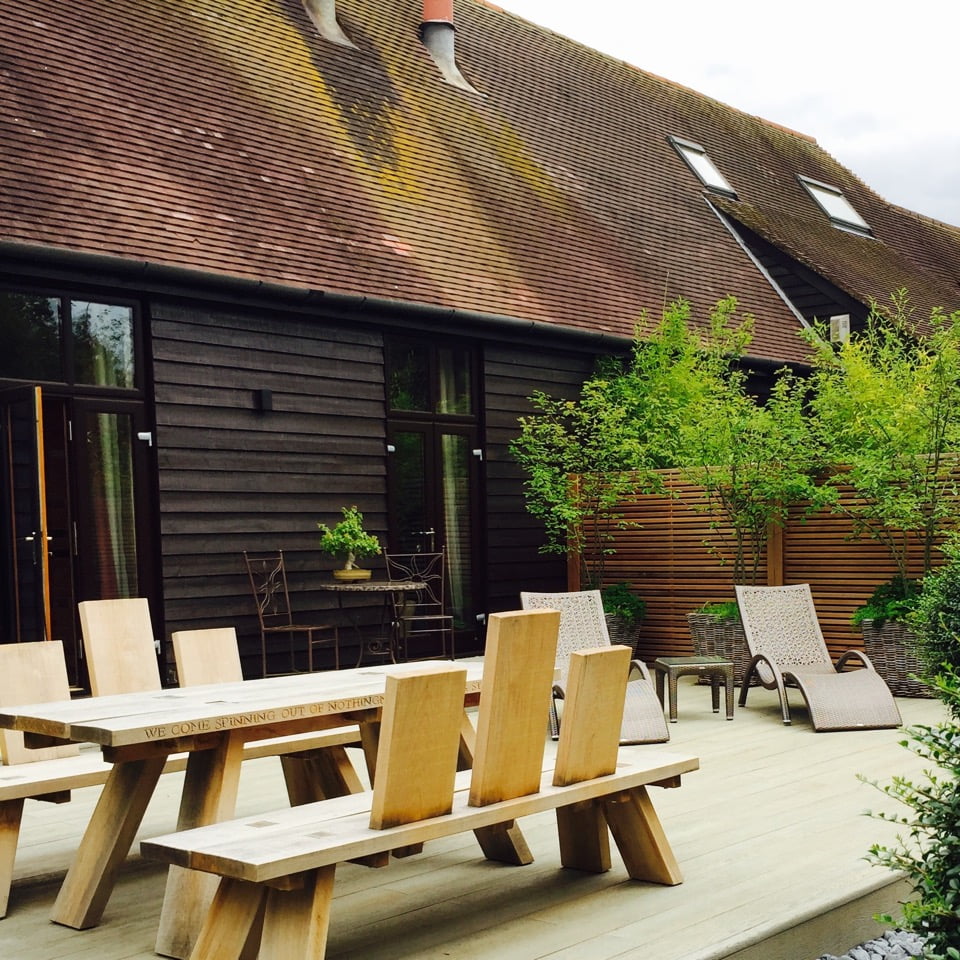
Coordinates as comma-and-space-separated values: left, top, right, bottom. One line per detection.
494, 0, 960, 225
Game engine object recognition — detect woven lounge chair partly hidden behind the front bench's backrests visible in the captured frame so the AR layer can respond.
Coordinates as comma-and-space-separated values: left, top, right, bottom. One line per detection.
520, 590, 670, 744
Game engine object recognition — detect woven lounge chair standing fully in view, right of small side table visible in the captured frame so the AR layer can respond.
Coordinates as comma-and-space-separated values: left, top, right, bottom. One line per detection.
736, 583, 901, 732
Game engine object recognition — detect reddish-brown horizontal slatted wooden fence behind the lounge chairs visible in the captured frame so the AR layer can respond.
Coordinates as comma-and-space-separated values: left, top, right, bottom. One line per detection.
568, 470, 939, 662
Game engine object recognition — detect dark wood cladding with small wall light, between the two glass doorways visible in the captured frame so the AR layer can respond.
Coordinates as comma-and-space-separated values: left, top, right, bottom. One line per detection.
151, 303, 386, 676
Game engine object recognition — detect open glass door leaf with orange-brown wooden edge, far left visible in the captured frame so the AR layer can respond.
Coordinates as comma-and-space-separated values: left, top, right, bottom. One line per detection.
0, 386, 51, 643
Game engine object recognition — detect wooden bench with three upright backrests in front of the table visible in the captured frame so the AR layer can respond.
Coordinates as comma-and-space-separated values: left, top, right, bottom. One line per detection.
141, 610, 699, 960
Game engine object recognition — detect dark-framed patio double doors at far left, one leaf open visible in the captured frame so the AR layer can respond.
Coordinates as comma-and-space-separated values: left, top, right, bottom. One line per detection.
0, 387, 156, 687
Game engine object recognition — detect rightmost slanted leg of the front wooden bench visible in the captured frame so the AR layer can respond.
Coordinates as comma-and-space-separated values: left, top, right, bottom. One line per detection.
601, 787, 683, 885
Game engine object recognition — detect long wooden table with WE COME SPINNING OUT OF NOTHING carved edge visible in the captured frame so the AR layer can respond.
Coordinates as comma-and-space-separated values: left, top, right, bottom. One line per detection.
0, 661, 532, 957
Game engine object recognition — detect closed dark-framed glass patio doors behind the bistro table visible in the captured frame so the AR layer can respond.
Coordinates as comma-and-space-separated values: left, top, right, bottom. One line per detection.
387, 338, 486, 651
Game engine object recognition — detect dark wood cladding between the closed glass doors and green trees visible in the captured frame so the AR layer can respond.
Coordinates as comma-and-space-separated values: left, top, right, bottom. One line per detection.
484, 345, 594, 612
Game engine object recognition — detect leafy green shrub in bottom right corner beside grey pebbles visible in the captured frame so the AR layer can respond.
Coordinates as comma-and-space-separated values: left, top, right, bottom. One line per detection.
861, 668, 960, 960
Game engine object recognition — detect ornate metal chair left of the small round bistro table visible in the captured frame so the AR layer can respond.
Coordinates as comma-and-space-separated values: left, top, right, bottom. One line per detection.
243, 550, 340, 677
